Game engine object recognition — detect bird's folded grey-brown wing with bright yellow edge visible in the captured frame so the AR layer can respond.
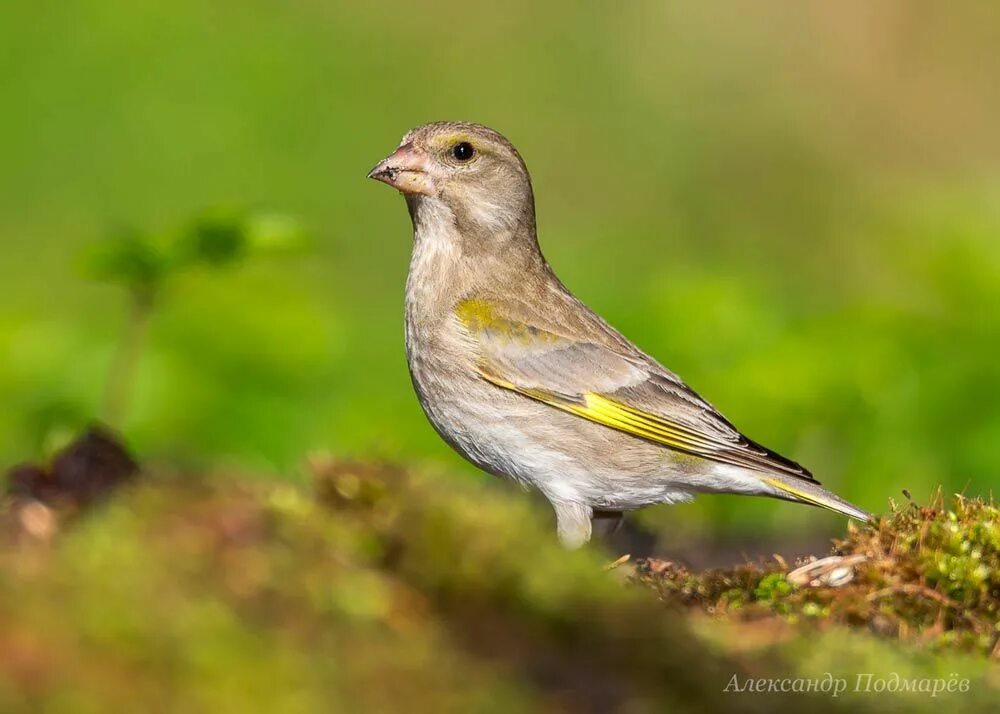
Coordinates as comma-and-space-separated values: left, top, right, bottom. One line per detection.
456, 300, 815, 481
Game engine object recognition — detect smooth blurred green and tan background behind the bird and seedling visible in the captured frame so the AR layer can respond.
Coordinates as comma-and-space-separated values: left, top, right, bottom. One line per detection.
0, 0, 1000, 535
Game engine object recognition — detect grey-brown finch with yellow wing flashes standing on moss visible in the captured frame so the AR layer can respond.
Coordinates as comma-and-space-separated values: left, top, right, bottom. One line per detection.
368, 121, 873, 549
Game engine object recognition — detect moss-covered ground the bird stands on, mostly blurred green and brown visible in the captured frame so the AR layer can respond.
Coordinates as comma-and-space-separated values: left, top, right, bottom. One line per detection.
0, 432, 1000, 714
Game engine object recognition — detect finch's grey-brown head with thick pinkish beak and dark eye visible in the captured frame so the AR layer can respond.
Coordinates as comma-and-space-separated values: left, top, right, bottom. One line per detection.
368, 122, 535, 235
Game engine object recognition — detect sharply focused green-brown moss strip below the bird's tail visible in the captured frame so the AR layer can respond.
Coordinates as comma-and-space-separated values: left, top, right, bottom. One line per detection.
637, 496, 1000, 657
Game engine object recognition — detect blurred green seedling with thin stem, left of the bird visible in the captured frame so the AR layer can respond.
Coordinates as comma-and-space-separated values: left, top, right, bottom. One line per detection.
85, 209, 305, 427
